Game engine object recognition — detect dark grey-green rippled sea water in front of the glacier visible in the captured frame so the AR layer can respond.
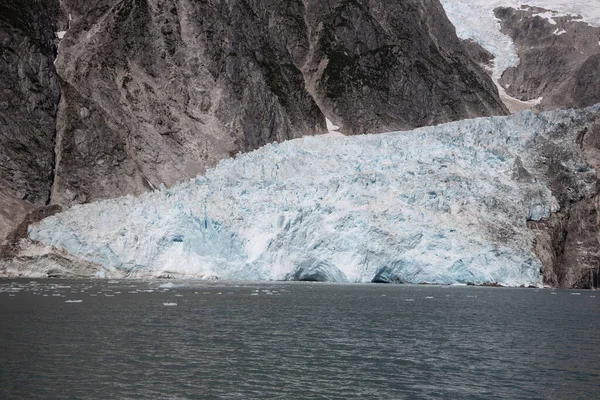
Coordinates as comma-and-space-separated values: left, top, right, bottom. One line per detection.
0, 280, 600, 399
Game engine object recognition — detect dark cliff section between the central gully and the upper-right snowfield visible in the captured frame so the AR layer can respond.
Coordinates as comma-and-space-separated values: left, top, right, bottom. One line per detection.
297, 0, 506, 134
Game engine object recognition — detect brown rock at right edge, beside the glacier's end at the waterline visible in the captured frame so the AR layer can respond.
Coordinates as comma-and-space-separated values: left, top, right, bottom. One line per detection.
528, 115, 600, 289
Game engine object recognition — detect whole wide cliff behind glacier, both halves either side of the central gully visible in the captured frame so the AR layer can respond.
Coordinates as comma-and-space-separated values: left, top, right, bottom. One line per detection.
52, 0, 506, 205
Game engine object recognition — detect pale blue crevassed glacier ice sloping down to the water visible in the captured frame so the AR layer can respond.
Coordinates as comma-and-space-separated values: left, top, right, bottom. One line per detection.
29, 106, 600, 286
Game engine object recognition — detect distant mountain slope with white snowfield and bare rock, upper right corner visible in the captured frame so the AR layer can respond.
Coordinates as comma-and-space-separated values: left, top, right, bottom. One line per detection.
442, 0, 600, 112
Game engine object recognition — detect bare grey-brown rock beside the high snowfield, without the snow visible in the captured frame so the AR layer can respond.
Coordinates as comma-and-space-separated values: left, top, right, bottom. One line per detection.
495, 6, 600, 110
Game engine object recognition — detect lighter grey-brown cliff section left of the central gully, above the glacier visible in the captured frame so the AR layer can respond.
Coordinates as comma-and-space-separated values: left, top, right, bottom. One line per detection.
52, 0, 326, 205
